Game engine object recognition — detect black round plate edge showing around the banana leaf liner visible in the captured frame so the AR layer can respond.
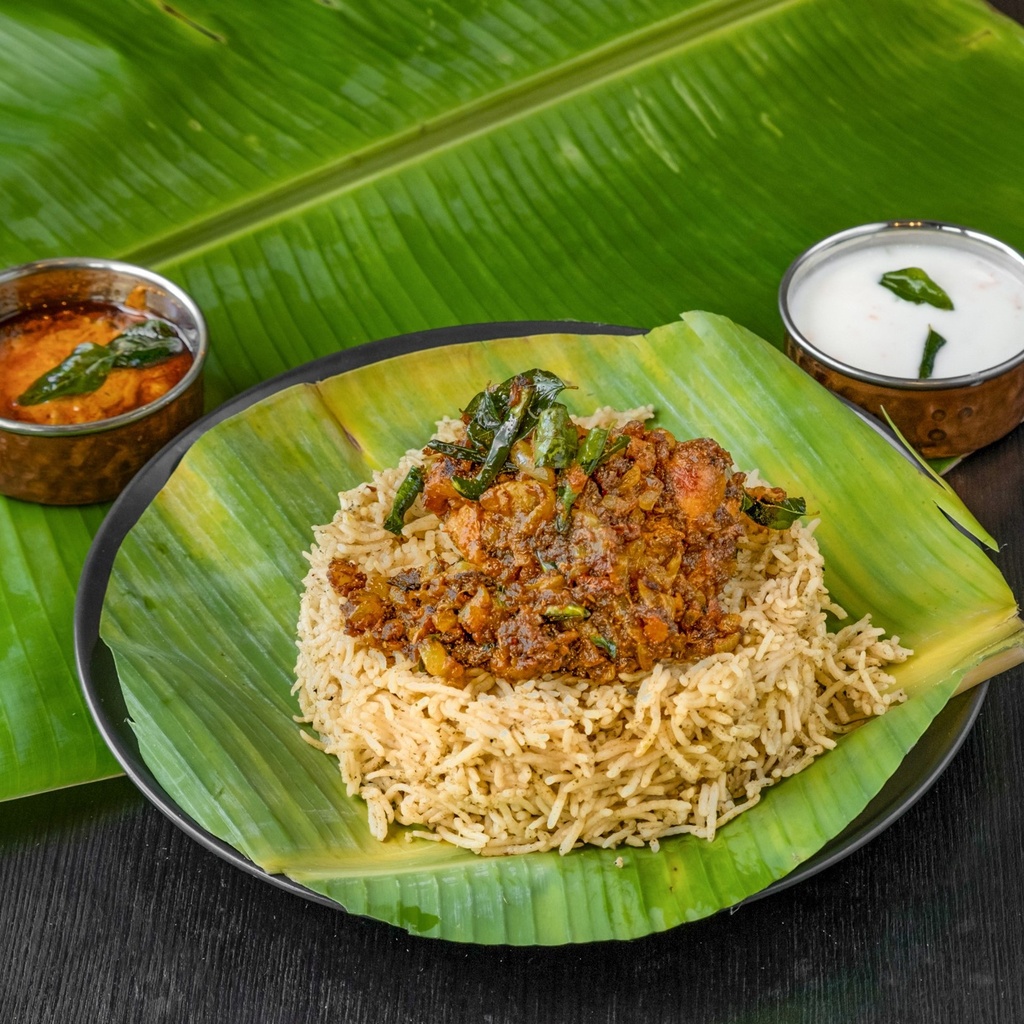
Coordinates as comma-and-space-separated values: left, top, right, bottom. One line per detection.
75, 321, 988, 907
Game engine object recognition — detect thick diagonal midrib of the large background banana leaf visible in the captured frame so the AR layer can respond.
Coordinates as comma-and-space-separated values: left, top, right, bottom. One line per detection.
119, 0, 806, 267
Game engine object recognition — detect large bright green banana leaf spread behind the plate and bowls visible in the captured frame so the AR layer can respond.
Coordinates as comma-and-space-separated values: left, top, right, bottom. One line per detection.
0, 0, 1024, 799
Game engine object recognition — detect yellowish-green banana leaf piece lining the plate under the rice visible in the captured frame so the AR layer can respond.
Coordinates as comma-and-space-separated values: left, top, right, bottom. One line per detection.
90, 313, 1024, 944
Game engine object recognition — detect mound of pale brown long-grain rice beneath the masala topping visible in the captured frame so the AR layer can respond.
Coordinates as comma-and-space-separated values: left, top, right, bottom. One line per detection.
294, 408, 911, 855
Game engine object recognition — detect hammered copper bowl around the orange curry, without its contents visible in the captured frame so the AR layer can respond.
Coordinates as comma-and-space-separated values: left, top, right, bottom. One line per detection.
0, 258, 208, 505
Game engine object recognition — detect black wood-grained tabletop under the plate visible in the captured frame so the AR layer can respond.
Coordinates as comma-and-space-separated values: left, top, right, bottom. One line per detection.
0, 0, 1024, 1024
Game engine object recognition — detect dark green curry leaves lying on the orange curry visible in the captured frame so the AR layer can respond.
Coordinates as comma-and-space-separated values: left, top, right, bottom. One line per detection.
17, 319, 184, 406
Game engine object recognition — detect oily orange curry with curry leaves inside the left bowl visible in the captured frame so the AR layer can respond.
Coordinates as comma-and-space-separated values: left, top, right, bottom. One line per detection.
0, 300, 193, 425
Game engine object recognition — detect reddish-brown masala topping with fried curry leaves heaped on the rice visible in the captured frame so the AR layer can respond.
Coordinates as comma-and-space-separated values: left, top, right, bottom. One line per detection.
329, 370, 804, 682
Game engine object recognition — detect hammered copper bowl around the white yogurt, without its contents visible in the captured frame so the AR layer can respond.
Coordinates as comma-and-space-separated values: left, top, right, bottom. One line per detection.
779, 220, 1024, 458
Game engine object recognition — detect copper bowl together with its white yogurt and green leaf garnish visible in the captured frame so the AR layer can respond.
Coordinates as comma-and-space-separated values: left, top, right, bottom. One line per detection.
779, 220, 1024, 458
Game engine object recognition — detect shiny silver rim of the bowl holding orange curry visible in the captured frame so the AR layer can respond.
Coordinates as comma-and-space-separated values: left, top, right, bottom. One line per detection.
0, 256, 210, 437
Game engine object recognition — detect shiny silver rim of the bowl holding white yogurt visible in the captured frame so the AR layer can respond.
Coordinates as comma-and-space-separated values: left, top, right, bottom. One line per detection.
778, 219, 1024, 391
